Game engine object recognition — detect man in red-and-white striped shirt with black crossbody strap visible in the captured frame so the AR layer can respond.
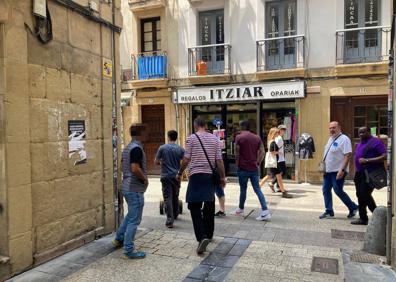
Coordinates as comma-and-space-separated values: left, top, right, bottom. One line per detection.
177, 117, 225, 254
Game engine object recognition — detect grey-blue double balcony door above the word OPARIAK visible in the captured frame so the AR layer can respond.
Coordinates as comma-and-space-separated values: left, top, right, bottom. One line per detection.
265, 0, 297, 70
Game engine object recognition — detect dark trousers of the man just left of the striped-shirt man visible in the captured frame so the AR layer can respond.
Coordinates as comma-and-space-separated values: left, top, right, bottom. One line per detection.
161, 177, 180, 224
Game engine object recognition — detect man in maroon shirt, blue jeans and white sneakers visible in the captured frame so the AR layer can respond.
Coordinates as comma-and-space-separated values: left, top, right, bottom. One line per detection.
233, 121, 271, 220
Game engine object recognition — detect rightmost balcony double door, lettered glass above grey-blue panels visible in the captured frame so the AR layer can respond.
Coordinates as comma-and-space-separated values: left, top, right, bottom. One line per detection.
344, 0, 381, 63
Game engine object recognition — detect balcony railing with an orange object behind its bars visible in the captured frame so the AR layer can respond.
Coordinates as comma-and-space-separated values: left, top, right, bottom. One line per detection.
188, 44, 231, 76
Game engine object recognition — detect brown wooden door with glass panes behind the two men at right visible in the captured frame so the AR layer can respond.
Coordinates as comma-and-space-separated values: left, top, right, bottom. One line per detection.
330, 95, 388, 180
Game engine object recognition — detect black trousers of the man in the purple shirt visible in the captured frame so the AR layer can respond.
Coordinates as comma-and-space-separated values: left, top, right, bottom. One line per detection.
354, 171, 377, 221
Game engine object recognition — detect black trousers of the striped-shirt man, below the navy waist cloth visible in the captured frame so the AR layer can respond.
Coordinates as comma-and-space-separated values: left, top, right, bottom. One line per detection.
188, 201, 215, 242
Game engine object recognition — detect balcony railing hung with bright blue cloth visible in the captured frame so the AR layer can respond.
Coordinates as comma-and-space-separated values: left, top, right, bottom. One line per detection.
122, 51, 168, 82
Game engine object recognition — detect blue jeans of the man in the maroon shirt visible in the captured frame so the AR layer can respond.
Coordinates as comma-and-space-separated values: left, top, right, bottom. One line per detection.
237, 169, 268, 211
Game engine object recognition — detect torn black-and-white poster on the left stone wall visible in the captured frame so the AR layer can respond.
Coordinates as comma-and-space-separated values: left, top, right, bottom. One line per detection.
68, 120, 87, 166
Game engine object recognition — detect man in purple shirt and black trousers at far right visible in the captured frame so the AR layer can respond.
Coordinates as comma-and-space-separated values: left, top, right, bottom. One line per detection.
351, 126, 386, 225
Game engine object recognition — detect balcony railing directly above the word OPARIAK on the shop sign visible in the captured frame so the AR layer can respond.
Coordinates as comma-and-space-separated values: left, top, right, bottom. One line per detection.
256, 35, 305, 71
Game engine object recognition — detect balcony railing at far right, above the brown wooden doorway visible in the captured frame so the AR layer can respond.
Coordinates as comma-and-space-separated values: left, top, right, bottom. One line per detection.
336, 26, 391, 64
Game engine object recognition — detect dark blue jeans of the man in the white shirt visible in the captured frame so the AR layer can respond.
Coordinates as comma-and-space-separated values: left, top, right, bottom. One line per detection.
322, 172, 358, 214
